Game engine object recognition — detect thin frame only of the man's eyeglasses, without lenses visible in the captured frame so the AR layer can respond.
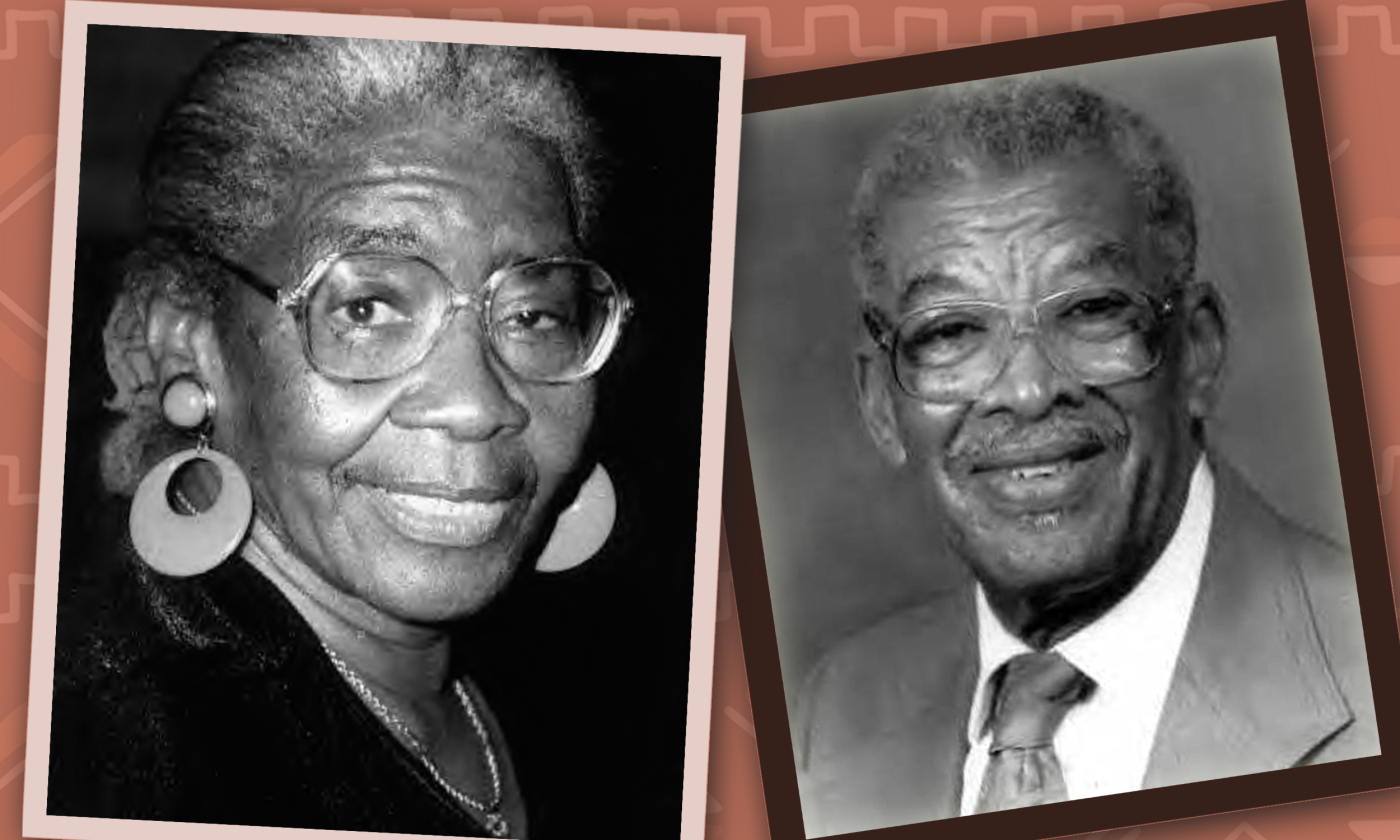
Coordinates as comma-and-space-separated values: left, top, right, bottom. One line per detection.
861, 283, 1200, 405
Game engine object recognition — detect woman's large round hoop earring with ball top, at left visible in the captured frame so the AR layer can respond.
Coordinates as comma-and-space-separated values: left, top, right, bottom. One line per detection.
130, 375, 253, 577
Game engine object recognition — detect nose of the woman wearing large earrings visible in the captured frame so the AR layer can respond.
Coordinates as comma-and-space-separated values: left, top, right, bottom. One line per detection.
389, 315, 529, 440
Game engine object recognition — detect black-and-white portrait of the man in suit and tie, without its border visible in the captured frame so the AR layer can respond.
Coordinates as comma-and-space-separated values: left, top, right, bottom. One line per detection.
725, 4, 1389, 837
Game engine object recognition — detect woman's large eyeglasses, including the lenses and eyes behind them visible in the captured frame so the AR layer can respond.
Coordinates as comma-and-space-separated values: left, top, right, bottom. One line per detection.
218, 253, 631, 384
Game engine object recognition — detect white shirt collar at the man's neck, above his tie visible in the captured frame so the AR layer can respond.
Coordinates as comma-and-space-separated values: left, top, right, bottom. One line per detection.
967, 455, 1215, 742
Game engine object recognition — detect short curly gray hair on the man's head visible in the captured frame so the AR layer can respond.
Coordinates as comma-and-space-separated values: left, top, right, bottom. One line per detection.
851, 78, 1196, 300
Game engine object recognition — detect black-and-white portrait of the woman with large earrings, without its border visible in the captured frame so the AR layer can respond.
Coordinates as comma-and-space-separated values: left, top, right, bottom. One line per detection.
48, 27, 720, 837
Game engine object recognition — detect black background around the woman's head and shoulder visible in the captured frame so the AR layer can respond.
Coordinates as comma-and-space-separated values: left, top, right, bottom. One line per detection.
60, 27, 720, 839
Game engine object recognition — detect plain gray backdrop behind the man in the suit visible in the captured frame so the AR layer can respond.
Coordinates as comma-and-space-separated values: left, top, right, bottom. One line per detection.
732, 39, 1348, 704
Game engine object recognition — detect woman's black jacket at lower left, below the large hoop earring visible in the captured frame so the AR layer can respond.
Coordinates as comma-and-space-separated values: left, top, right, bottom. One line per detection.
49, 534, 498, 837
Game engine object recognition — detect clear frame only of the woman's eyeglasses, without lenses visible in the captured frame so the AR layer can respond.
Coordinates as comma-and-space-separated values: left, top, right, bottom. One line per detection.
210, 251, 636, 385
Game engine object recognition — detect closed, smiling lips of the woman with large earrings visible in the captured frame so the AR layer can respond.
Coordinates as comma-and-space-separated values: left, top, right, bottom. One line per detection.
365, 486, 519, 549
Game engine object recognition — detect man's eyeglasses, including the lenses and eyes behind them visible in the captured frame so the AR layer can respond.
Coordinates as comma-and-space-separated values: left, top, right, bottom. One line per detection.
862, 286, 1176, 403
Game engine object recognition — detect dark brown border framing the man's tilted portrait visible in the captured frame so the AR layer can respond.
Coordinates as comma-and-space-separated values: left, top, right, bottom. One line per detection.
724, 0, 1400, 840
